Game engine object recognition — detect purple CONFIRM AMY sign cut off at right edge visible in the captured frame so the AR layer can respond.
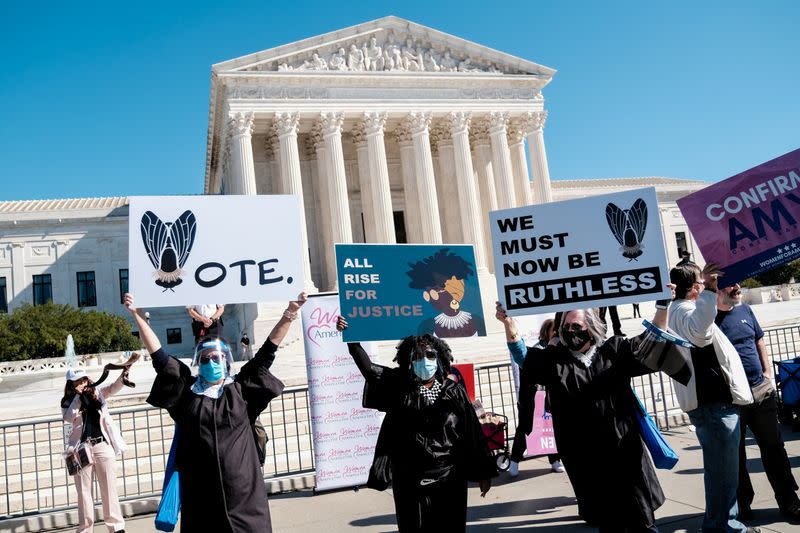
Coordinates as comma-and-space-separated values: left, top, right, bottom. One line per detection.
678, 149, 800, 285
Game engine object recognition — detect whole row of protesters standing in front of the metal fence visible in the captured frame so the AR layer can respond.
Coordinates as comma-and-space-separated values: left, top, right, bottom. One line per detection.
61, 261, 800, 533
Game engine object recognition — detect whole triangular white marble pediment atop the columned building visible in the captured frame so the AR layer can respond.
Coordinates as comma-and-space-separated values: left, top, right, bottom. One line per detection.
213, 16, 555, 81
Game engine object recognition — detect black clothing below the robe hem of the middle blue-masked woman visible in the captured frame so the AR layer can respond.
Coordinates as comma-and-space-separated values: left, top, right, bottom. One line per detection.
392, 475, 467, 533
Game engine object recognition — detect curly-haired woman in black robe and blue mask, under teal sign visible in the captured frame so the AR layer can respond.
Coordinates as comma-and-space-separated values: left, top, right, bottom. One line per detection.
337, 316, 497, 533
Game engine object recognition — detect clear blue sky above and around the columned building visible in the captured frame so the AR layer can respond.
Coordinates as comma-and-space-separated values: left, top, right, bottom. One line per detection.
0, 0, 800, 200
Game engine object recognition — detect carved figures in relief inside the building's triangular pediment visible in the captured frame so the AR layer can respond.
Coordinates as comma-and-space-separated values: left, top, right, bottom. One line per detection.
268, 35, 523, 74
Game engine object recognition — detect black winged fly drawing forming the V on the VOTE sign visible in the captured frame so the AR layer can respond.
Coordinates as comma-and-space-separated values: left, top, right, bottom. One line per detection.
141, 210, 197, 291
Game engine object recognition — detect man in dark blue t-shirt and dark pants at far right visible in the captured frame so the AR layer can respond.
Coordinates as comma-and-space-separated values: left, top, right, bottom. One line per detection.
715, 283, 800, 521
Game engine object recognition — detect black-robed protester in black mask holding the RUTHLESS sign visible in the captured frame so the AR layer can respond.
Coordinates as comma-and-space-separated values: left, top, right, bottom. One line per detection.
496, 290, 680, 532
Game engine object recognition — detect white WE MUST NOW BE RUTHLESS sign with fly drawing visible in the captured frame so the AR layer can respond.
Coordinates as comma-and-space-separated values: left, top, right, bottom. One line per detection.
489, 187, 670, 316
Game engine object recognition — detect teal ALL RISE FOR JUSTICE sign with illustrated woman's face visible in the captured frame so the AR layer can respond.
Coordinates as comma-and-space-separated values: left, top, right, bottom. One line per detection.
336, 244, 486, 342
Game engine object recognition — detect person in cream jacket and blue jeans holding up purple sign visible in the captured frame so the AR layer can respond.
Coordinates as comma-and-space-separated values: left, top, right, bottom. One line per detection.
669, 262, 758, 532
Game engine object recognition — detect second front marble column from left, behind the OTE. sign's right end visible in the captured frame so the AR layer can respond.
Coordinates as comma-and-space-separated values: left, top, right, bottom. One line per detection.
275, 112, 317, 292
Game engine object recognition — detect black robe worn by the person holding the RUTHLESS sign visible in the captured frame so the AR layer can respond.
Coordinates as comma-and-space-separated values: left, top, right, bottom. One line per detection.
520, 336, 664, 527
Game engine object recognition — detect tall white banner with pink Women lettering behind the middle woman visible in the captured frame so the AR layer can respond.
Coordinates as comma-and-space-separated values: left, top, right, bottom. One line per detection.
302, 294, 383, 490
